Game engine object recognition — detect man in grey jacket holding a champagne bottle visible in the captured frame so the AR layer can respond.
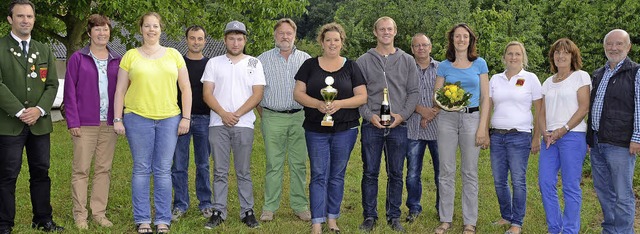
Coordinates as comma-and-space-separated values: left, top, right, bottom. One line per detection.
357, 16, 420, 232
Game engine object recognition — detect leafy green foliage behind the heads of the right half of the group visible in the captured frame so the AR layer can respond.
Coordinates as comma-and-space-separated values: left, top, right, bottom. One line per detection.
335, 0, 640, 79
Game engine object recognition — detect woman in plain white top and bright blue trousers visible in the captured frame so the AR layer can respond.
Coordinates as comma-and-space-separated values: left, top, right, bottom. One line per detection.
537, 38, 591, 233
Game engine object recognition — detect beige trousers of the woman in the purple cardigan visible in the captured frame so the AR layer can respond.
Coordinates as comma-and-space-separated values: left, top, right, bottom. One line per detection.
71, 122, 118, 220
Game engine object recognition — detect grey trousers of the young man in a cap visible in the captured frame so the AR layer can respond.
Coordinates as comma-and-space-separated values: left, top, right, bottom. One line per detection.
209, 126, 254, 219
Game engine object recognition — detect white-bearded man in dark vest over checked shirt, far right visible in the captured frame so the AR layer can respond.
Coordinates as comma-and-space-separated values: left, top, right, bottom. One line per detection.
587, 29, 640, 233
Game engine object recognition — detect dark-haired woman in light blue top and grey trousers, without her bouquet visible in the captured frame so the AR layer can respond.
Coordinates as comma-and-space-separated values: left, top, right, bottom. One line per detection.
435, 24, 490, 233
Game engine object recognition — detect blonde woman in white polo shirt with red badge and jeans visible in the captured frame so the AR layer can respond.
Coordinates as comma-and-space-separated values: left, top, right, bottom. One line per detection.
489, 41, 542, 234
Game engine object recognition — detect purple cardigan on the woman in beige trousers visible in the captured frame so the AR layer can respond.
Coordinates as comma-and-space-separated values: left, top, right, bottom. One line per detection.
64, 46, 122, 128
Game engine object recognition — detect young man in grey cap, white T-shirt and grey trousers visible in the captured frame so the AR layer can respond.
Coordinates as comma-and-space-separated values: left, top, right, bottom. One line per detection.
201, 21, 266, 229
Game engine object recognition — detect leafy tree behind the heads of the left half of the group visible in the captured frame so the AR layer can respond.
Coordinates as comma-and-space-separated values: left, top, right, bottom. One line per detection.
0, 0, 308, 57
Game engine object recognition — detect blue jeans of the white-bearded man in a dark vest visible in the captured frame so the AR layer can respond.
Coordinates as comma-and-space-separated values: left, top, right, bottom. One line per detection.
591, 134, 636, 233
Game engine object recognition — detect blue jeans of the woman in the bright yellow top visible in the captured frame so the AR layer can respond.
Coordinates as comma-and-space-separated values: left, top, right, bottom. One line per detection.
123, 113, 181, 225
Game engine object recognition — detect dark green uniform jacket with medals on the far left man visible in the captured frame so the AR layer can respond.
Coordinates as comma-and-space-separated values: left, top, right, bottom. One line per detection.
0, 34, 58, 136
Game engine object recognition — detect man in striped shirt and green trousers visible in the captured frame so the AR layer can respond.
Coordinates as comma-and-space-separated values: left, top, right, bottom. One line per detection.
258, 18, 311, 221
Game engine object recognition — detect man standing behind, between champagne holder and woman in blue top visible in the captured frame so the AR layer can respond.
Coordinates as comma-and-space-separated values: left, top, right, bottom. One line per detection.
406, 33, 440, 222
